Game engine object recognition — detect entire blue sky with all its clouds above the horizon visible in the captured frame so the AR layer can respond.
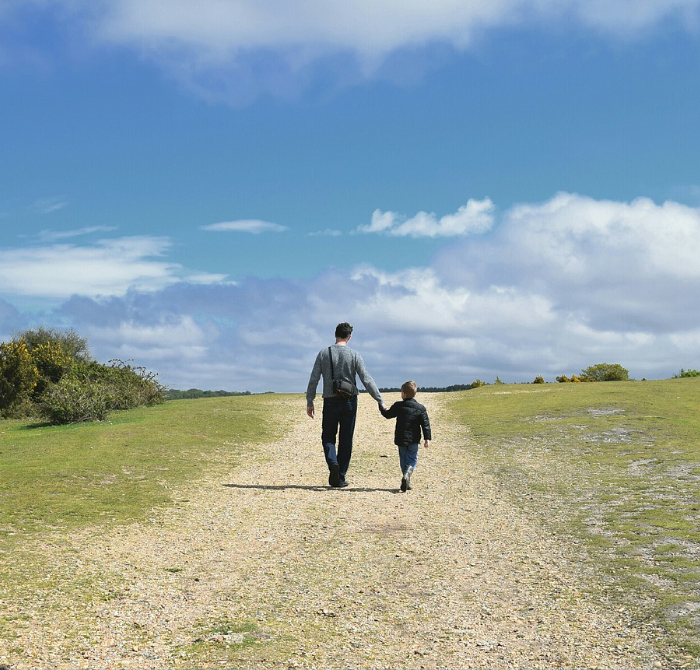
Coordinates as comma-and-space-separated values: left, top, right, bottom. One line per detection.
0, 0, 700, 392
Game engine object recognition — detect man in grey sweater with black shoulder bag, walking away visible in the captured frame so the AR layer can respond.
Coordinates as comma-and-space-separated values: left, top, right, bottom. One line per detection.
306, 323, 384, 487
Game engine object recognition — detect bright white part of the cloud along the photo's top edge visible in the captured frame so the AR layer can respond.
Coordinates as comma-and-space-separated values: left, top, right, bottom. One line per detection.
91, 0, 698, 61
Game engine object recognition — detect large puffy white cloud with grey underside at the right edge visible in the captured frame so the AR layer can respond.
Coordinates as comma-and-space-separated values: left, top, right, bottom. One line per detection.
436, 193, 700, 332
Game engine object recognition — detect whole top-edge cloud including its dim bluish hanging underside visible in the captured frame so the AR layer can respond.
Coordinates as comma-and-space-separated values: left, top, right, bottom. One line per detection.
8, 0, 700, 104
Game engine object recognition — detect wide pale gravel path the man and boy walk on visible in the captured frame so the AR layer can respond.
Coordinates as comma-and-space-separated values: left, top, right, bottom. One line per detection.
0, 394, 662, 670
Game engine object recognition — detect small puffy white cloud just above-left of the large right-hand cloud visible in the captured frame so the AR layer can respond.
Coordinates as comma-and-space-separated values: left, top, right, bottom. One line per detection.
358, 198, 495, 237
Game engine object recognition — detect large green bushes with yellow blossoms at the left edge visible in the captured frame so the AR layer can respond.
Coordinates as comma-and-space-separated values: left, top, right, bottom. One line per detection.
0, 326, 165, 424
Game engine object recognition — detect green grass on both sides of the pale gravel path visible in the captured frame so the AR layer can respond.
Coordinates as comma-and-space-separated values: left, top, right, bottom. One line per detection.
0, 379, 700, 660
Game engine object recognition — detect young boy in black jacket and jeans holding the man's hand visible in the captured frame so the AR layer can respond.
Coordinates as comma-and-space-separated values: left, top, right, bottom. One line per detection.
379, 381, 432, 491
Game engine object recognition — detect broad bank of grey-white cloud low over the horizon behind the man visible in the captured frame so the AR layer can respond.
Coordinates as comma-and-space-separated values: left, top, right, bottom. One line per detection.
8, 193, 700, 392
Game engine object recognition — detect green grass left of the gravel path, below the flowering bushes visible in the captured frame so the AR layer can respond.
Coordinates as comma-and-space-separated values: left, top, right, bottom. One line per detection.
0, 394, 284, 551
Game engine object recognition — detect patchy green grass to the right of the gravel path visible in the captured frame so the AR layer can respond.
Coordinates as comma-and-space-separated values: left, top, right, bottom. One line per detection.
451, 379, 700, 659
